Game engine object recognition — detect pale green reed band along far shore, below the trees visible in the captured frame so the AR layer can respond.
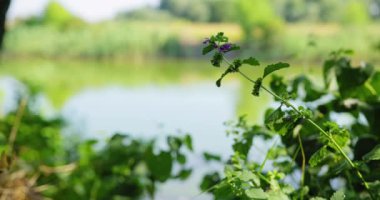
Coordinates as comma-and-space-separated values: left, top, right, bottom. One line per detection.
3, 20, 380, 61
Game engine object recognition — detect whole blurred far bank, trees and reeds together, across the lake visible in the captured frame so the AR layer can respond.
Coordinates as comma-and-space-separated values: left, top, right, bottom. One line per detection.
4, 0, 380, 59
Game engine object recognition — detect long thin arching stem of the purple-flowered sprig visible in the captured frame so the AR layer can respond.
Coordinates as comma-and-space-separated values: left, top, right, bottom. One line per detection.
223, 56, 374, 199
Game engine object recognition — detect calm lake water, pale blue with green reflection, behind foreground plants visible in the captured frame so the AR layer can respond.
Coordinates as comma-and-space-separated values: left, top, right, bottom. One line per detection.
0, 57, 320, 199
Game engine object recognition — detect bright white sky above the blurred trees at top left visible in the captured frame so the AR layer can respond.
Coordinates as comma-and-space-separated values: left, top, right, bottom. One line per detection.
8, 0, 160, 22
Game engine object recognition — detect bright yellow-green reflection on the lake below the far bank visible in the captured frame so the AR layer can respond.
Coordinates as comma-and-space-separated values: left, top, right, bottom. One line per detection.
0, 58, 321, 122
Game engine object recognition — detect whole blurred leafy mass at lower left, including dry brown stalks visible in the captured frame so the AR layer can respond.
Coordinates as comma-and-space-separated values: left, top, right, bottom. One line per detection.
0, 94, 193, 200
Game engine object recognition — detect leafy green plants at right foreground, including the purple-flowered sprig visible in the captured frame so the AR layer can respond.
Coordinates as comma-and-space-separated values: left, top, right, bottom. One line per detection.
201, 33, 380, 200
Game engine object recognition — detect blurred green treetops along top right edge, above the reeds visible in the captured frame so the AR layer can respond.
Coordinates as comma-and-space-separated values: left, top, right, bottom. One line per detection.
120, 0, 380, 23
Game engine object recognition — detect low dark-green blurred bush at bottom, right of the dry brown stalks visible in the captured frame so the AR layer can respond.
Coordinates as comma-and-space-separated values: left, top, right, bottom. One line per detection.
41, 134, 192, 199
